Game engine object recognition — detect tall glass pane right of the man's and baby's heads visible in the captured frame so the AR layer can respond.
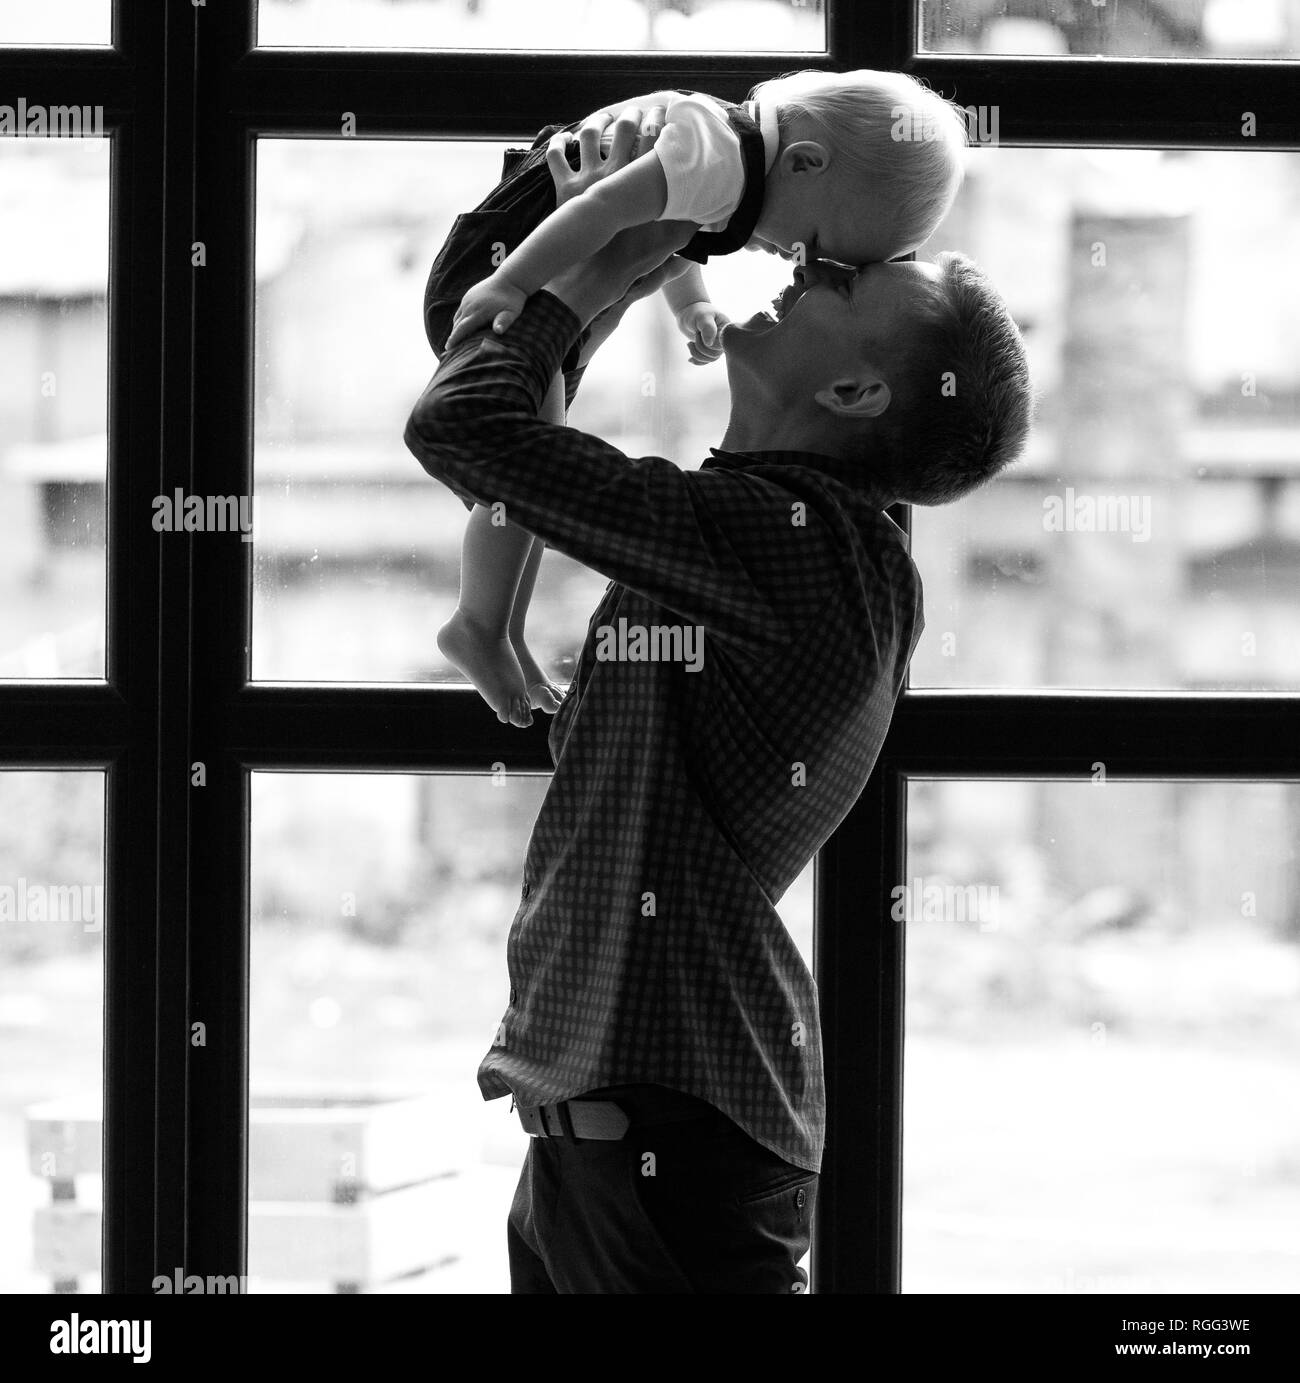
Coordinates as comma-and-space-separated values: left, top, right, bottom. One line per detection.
911, 148, 1300, 690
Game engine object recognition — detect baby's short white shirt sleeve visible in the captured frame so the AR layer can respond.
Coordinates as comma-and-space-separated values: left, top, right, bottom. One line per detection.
654, 95, 745, 231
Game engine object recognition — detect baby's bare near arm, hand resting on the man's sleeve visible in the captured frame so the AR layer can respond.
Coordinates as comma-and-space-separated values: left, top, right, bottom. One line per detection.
447, 147, 668, 350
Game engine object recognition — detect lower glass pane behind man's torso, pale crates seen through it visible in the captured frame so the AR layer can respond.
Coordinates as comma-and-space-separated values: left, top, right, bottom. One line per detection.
249, 773, 812, 1293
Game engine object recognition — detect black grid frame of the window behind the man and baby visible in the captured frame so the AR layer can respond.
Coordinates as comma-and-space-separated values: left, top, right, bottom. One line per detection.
0, 0, 1300, 1293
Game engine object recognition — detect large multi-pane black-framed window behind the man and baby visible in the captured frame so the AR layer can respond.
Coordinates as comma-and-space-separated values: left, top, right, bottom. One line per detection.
0, 0, 1300, 1293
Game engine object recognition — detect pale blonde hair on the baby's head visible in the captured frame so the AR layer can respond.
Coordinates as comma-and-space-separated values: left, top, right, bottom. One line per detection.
750, 68, 967, 259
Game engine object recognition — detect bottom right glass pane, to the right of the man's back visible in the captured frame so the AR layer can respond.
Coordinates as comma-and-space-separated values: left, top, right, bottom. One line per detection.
893, 781, 1300, 1294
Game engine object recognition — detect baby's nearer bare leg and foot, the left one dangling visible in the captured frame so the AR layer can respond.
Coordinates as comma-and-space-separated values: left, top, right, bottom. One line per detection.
437, 505, 532, 726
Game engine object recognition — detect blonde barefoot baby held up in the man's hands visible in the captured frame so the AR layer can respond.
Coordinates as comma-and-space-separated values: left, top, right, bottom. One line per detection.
425, 71, 967, 726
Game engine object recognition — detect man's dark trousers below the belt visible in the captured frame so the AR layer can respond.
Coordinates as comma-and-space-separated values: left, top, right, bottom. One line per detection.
508, 1089, 817, 1294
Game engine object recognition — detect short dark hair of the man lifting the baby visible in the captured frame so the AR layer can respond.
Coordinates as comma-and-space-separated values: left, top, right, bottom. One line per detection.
867, 252, 1033, 505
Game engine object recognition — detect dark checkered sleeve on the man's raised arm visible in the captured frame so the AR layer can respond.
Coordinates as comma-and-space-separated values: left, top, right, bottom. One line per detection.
405, 292, 844, 656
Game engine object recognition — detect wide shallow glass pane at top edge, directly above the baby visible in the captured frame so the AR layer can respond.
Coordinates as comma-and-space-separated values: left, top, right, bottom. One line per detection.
257, 0, 826, 53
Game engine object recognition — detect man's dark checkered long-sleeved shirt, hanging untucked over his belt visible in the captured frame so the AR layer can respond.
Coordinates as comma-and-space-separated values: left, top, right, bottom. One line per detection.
405, 292, 922, 1170
